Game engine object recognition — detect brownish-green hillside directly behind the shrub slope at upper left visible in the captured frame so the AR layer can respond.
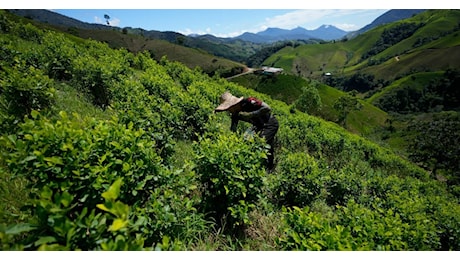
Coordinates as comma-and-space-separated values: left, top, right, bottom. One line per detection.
3, 10, 246, 77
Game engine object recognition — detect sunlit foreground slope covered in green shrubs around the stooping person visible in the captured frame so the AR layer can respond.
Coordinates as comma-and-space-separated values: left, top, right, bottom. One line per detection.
0, 11, 460, 251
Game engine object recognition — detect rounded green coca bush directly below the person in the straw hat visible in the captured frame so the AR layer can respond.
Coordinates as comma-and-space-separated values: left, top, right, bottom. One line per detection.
194, 133, 267, 233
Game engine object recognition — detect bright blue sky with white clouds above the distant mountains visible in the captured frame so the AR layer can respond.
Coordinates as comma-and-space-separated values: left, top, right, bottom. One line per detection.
4, 0, 460, 37
